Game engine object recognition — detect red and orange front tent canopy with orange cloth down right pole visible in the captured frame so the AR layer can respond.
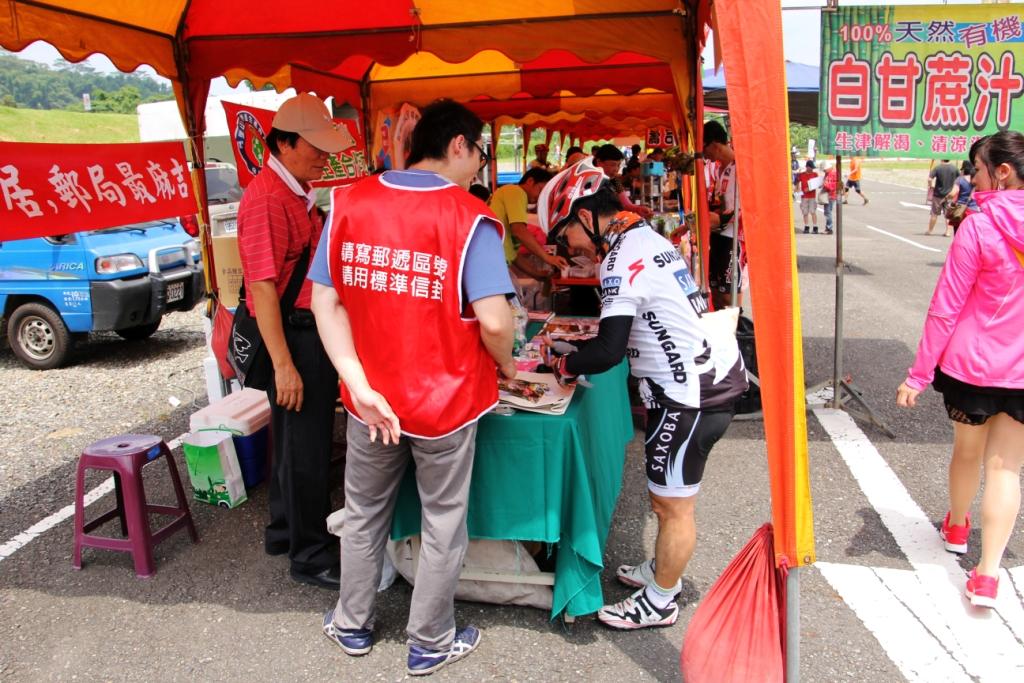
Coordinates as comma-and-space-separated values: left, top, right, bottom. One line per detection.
0, 0, 814, 566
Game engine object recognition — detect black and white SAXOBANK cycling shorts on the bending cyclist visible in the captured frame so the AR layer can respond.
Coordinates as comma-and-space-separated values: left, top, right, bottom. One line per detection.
644, 405, 732, 498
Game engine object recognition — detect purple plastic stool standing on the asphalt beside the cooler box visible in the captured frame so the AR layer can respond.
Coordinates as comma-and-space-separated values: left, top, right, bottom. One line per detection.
72, 434, 199, 579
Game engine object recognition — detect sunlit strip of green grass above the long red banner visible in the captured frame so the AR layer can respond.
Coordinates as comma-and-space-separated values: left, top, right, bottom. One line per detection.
0, 106, 138, 142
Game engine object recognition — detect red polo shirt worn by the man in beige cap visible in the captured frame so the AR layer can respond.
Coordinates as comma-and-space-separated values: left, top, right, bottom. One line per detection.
239, 161, 324, 315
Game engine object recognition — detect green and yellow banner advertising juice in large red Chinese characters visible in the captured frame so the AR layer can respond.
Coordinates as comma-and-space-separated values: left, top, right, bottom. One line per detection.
818, 4, 1024, 159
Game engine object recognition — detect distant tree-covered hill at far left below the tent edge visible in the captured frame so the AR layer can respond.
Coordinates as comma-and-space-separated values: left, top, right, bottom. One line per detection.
0, 50, 174, 114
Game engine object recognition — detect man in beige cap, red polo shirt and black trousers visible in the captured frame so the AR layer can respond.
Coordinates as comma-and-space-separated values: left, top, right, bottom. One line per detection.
238, 93, 350, 590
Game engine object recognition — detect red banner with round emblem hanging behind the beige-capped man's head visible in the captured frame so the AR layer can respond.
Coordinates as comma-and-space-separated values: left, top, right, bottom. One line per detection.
222, 102, 370, 187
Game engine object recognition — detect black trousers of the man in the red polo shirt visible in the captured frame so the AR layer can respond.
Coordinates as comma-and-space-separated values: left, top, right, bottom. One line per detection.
265, 322, 339, 572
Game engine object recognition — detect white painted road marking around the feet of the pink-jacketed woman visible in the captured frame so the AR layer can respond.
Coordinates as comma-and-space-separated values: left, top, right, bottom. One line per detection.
814, 409, 1024, 681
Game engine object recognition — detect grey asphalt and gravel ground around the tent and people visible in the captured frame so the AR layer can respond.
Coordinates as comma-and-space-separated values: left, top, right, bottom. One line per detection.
0, 180, 1024, 681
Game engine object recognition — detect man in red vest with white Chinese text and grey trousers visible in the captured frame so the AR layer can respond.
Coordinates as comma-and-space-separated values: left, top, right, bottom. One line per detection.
301, 100, 516, 675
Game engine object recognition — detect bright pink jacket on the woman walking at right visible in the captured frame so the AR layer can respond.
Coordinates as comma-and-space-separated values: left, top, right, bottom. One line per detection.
906, 189, 1024, 391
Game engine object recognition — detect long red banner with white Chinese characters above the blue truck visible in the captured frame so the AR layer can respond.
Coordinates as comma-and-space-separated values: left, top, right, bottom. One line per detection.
0, 141, 197, 240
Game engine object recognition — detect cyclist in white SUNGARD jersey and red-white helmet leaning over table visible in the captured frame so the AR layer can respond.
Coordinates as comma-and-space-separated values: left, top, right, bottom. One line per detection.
538, 160, 746, 629
